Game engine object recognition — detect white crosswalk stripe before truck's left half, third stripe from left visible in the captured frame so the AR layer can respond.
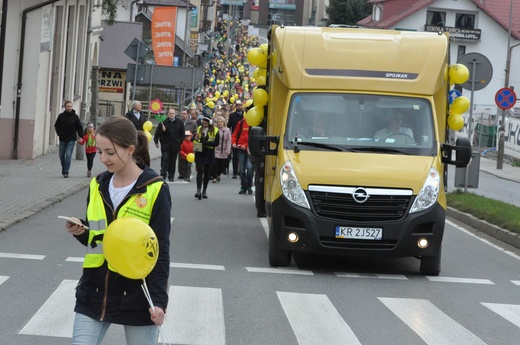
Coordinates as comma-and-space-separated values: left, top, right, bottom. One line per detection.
276, 291, 361, 345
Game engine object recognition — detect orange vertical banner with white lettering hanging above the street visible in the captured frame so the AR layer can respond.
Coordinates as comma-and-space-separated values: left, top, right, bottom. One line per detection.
152, 6, 177, 66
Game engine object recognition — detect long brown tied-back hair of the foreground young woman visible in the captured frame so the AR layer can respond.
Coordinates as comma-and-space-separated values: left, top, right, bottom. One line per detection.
96, 115, 150, 166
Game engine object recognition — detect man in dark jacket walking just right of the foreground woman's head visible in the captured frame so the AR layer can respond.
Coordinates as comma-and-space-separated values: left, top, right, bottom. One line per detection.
154, 108, 185, 182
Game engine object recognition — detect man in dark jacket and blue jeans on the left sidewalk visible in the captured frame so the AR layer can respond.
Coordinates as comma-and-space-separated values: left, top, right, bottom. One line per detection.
54, 101, 83, 178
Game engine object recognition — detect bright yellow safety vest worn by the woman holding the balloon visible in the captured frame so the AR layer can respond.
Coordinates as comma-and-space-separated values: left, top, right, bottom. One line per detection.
83, 179, 163, 271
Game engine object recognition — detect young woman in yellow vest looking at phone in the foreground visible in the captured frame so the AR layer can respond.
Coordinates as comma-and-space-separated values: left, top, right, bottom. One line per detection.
66, 116, 172, 345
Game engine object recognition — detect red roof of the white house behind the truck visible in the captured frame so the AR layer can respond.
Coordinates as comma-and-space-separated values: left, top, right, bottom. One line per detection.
357, 0, 520, 39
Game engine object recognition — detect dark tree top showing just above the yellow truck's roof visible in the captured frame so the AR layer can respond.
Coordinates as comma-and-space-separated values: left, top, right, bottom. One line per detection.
325, 0, 372, 25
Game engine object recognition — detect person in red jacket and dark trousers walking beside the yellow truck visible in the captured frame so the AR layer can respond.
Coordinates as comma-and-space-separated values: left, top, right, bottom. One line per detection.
231, 118, 253, 194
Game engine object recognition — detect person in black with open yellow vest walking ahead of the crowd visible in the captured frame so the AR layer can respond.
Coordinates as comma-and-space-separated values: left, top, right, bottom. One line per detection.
193, 116, 220, 200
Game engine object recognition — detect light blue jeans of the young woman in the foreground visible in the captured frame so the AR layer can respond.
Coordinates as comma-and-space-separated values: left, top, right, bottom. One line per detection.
72, 313, 159, 345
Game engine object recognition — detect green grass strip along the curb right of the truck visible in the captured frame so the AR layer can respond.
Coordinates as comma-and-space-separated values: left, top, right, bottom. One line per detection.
446, 190, 520, 234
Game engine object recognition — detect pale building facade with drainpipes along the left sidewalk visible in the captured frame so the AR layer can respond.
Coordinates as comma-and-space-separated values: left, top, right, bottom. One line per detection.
0, 0, 102, 159
